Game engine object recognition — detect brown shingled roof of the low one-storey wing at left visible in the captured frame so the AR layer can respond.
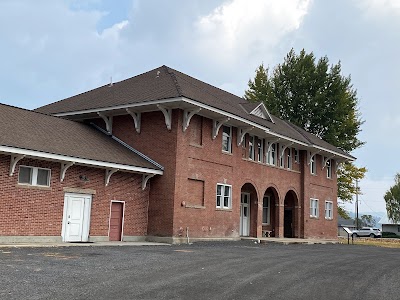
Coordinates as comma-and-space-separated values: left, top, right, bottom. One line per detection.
0, 104, 161, 173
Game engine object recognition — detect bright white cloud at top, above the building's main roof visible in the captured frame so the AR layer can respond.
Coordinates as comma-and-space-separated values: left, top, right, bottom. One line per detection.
195, 0, 311, 64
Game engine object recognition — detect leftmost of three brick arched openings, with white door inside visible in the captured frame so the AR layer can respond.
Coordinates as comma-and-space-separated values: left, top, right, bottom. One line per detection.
239, 183, 258, 236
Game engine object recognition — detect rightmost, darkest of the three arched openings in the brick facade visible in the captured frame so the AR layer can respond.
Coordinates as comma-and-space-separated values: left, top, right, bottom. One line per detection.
283, 190, 298, 238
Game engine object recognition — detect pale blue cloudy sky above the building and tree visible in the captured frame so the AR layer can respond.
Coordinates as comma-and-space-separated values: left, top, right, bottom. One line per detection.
0, 0, 400, 213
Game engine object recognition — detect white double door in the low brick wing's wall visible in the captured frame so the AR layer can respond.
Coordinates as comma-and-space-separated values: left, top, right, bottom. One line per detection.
61, 194, 92, 242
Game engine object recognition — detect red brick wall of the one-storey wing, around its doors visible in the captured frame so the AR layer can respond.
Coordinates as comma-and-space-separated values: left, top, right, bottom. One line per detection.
0, 155, 149, 236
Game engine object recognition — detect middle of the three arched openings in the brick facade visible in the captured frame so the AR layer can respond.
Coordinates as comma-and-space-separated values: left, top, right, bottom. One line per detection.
262, 187, 279, 237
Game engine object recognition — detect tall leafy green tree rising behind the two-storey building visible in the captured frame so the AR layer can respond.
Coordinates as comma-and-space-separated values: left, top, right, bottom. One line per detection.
245, 49, 366, 216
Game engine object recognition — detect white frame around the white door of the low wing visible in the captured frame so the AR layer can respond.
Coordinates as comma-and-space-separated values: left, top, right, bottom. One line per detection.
61, 193, 93, 242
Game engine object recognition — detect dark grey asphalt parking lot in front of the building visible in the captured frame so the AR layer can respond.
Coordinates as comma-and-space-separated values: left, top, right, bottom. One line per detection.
0, 241, 400, 300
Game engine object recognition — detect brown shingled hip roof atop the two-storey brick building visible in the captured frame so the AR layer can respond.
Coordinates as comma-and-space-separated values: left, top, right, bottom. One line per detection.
36, 66, 353, 159
